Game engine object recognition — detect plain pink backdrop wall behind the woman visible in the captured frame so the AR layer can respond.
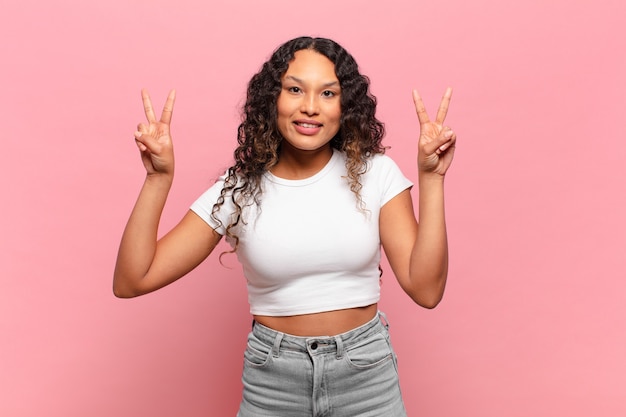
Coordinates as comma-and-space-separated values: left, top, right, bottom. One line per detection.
0, 0, 626, 417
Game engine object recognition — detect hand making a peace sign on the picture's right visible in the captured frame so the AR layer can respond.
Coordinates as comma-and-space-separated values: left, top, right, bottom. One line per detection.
413, 88, 456, 176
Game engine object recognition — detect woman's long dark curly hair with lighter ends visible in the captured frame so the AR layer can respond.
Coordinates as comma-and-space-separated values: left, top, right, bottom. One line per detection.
212, 37, 385, 253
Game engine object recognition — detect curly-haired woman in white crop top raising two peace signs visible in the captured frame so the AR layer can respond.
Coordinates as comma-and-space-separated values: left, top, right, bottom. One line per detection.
113, 37, 456, 417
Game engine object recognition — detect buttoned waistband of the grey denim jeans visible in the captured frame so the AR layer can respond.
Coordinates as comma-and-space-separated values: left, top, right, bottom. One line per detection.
247, 311, 389, 358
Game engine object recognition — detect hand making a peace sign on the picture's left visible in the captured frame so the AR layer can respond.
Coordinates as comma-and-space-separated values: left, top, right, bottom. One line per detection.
135, 89, 176, 177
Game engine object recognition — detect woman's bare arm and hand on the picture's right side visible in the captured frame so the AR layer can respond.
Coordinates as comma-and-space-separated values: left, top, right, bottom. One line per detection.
380, 88, 456, 308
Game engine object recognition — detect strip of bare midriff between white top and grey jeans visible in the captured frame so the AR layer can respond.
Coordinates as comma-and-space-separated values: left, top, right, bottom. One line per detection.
254, 304, 378, 337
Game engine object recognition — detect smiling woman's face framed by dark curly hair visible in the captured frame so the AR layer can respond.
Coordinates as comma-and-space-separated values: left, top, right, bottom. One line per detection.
276, 49, 341, 151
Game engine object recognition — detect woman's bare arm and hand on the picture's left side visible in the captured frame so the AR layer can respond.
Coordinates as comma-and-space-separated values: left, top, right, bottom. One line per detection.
113, 90, 221, 298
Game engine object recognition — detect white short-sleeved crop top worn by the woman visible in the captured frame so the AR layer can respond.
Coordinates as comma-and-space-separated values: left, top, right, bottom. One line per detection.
191, 151, 412, 316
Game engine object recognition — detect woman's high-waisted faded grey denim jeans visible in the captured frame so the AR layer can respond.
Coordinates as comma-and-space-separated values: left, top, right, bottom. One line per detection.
237, 313, 406, 417
